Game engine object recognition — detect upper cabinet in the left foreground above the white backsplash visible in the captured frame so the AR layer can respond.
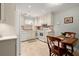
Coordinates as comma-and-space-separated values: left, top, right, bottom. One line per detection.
1, 3, 16, 26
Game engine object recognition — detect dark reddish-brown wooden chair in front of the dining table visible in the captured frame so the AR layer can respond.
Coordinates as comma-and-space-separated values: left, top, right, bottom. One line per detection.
47, 36, 67, 56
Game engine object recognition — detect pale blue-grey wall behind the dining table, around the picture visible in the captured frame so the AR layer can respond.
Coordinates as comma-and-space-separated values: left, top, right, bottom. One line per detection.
54, 7, 79, 38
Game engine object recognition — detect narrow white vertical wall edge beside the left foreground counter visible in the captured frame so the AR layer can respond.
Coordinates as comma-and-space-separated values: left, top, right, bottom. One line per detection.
15, 8, 21, 55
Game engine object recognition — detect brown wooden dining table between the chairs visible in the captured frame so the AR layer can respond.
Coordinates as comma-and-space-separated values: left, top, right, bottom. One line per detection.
47, 35, 78, 56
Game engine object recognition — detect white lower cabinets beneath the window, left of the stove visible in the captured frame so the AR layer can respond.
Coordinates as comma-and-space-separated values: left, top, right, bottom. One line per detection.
20, 30, 36, 41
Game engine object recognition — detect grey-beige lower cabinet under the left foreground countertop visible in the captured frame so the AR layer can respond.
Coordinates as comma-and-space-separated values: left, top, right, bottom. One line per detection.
0, 39, 16, 56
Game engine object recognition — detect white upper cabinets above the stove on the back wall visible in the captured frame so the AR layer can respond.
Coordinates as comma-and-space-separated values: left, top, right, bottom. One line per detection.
36, 13, 53, 26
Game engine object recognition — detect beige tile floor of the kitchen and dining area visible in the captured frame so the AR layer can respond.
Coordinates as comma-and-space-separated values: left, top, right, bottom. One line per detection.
21, 40, 79, 56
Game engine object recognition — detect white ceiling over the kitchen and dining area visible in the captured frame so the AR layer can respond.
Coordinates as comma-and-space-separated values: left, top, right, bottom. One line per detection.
16, 3, 79, 17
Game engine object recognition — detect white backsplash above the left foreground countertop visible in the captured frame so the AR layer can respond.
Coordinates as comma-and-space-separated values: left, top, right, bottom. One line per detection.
0, 23, 16, 36
